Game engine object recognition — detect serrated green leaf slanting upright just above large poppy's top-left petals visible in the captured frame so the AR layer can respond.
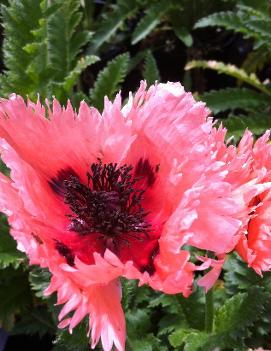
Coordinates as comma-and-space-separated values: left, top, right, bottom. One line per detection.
90, 53, 129, 110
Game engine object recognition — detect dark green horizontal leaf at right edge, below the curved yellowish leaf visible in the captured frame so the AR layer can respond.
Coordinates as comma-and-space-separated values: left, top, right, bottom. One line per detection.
199, 88, 271, 114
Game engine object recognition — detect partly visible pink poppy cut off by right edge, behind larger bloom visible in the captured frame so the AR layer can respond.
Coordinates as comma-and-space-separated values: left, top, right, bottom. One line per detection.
211, 129, 271, 274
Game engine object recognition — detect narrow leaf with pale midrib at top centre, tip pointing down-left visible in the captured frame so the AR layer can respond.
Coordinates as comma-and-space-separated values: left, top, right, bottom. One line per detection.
132, 0, 170, 45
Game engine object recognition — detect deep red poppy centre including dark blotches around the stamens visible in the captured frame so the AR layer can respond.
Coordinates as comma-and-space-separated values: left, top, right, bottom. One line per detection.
48, 158, 161, 274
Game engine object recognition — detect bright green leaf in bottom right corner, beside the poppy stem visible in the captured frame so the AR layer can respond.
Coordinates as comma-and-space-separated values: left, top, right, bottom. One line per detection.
169, 287, 269, 351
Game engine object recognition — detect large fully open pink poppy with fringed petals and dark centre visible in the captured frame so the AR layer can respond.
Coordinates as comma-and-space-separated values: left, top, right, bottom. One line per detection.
0, 83, 240, 351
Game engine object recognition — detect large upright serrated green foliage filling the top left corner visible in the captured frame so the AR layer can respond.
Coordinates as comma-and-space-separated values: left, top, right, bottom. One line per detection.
2, 0, 97, 102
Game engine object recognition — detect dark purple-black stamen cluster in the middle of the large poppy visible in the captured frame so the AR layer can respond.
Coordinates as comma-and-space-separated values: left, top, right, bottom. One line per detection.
64, 160, 151, 244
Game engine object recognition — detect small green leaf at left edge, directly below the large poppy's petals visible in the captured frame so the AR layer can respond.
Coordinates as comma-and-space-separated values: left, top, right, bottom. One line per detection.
0, 215, 25, 269
